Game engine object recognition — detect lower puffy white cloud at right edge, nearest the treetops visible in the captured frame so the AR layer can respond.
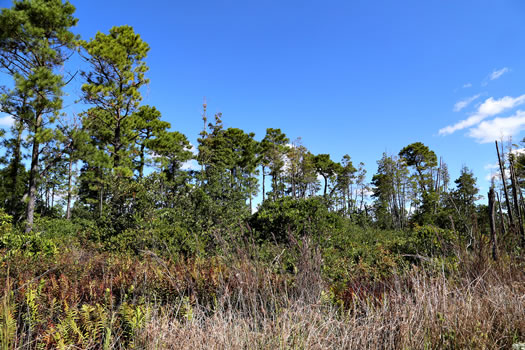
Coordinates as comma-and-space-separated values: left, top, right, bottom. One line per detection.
468, 110, 525, 143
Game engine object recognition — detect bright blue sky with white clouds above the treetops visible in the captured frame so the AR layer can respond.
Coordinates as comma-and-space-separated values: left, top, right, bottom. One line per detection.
0, 0, 525, 200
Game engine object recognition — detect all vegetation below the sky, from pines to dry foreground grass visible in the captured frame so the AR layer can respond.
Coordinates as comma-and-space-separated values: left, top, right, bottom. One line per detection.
0, 0, 525, 349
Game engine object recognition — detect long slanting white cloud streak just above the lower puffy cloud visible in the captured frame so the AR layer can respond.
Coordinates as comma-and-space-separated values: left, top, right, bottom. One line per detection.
439, 95, 525, 135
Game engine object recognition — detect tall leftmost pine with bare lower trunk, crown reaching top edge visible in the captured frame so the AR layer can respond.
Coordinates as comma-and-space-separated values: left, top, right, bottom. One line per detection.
0, 0, 77, 232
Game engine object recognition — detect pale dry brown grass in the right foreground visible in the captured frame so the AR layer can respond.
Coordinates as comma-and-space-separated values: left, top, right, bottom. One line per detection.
137, 258, 525, 349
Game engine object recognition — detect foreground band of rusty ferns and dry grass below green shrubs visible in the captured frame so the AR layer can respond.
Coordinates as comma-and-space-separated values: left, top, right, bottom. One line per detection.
0, 240, 525, 349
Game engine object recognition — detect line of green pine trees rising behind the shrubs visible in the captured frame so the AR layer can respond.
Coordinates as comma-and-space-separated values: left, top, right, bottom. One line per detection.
0, 1, 525, 247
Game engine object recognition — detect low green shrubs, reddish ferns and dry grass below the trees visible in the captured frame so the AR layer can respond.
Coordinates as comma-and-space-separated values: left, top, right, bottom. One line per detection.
0, 216, 525, 349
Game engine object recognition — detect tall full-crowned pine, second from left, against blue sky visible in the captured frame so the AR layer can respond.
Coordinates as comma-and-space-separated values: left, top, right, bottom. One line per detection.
82, 26, 149, 215
